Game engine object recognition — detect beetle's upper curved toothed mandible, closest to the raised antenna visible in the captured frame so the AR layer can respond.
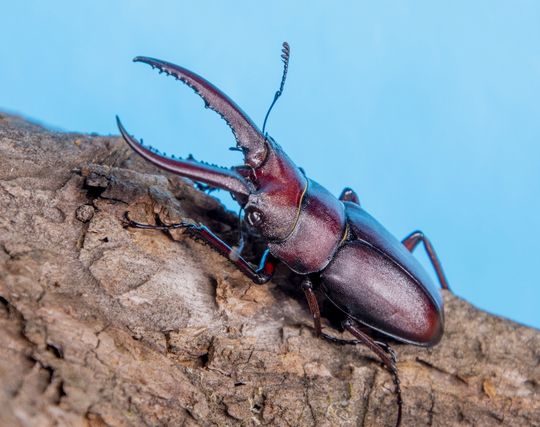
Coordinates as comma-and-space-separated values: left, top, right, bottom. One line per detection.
133, 56, 266, 168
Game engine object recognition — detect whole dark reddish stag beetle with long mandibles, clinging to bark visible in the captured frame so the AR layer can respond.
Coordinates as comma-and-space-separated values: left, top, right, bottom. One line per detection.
116, 42, 448, 425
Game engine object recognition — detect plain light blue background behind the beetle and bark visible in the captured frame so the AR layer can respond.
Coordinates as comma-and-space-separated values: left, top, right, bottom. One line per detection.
0, 0, 540, 327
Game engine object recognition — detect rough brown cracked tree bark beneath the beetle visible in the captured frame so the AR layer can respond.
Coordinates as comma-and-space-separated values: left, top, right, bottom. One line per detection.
0, 115, 540, 426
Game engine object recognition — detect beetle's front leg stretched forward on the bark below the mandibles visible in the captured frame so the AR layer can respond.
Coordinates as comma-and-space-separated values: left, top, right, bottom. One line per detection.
125, 212, 277, 285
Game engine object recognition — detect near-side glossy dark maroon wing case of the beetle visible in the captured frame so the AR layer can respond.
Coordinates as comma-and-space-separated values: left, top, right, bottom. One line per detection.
321, 240, 443, 346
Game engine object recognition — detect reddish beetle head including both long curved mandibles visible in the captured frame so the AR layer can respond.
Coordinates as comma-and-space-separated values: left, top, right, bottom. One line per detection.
117, 57, 307, 241
